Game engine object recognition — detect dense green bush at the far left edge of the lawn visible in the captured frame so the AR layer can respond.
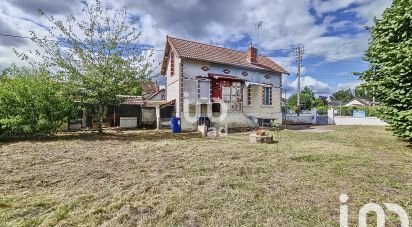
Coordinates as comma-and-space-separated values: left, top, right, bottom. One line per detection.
0, 70, 73, 138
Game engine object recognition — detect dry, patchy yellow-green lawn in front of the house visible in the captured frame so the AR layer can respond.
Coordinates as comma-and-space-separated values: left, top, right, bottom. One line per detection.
0, 127, 412, 226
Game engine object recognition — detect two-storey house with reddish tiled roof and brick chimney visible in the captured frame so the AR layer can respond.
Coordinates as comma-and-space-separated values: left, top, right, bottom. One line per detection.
161, 36, 288, 130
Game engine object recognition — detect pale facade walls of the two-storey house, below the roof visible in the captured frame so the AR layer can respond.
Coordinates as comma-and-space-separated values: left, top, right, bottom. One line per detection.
165, 56, 282, 130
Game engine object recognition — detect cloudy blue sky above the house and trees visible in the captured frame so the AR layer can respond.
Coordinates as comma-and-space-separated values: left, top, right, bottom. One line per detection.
0, 0, 391, 95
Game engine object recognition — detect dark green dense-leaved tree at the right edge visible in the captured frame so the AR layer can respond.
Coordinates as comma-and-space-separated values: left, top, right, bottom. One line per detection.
361, 0, 412, 142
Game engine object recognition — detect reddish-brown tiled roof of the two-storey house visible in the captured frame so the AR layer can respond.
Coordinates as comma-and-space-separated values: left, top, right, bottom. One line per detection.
162, 37, 289, 75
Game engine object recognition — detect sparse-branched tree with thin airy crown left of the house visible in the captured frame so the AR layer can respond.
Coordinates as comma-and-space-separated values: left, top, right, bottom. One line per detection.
16, 0, 153, 132
